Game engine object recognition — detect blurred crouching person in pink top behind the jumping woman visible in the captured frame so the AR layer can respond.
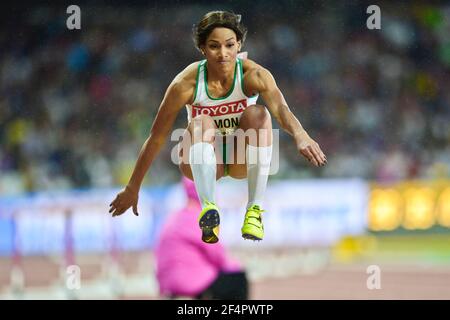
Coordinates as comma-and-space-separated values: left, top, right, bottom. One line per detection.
155, 177, 247, 299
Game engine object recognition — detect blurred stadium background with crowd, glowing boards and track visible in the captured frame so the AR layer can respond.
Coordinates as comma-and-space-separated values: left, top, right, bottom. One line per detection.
0, 1, 450, 299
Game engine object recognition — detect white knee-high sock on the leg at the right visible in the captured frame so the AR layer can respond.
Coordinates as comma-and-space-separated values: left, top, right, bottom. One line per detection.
247, 145, 272, 209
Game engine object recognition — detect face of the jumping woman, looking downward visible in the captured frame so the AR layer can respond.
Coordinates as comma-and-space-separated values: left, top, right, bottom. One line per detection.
202, 28, 241, 69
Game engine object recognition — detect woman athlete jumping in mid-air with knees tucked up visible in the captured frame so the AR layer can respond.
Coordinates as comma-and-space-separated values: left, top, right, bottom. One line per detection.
109, 11, 327, 243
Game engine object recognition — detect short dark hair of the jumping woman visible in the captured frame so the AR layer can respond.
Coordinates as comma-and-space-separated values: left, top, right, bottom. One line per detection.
192, 11, 247, 52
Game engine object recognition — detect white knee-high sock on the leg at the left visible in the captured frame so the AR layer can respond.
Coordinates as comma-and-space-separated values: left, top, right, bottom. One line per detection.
189, 142, 216, 208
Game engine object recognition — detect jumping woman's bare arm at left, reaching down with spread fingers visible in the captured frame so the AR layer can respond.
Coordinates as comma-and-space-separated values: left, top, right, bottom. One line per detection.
109, 62, 198, 217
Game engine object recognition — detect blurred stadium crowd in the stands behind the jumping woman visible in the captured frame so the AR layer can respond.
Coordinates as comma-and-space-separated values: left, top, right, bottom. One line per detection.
0, 1, 450, 195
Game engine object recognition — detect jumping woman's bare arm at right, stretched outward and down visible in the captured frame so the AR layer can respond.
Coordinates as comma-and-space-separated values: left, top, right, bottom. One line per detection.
243, 59, 327, 166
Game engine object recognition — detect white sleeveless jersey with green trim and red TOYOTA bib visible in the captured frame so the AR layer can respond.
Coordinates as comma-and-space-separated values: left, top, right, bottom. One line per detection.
186, 58, 258, 135
